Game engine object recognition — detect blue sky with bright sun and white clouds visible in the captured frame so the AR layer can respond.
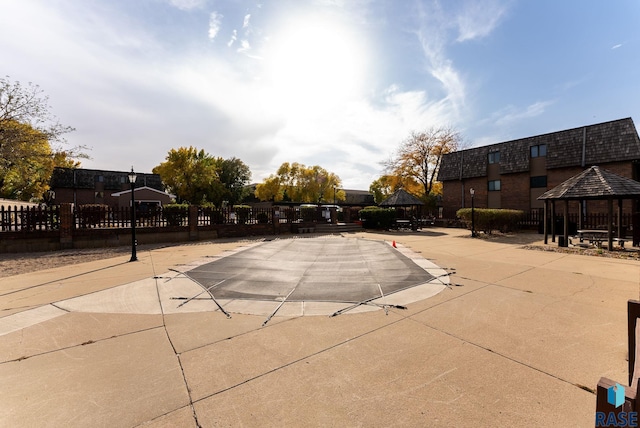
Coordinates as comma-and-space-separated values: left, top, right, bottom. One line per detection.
0, 0, 640, 190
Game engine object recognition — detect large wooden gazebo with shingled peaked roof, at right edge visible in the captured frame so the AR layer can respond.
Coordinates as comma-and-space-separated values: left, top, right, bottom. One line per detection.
538, 166, 640, 249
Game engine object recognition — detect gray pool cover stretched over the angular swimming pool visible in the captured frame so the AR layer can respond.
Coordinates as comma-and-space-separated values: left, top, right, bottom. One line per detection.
186, 237, 434, 302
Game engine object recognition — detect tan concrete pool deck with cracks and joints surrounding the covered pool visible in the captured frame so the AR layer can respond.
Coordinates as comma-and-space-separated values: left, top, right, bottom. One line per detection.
0, 229, 640, 427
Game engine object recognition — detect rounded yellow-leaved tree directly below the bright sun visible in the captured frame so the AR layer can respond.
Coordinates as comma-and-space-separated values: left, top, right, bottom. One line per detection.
255, 162, 345, 204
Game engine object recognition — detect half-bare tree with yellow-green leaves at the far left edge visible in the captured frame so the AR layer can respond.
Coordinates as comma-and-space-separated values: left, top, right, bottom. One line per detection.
0, 77, 88, 201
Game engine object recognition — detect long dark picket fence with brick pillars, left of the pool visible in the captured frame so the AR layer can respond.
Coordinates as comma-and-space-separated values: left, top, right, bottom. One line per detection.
0, 204, 361, 253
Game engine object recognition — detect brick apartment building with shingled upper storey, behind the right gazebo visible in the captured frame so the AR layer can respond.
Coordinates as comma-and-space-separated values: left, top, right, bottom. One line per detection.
438, 118, 640, 217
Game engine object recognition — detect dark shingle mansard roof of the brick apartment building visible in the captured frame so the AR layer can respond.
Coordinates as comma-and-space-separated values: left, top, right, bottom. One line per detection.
438, 118, 640, 181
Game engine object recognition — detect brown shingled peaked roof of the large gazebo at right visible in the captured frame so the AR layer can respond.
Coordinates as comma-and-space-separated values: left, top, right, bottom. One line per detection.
538, 166, 640, 200
